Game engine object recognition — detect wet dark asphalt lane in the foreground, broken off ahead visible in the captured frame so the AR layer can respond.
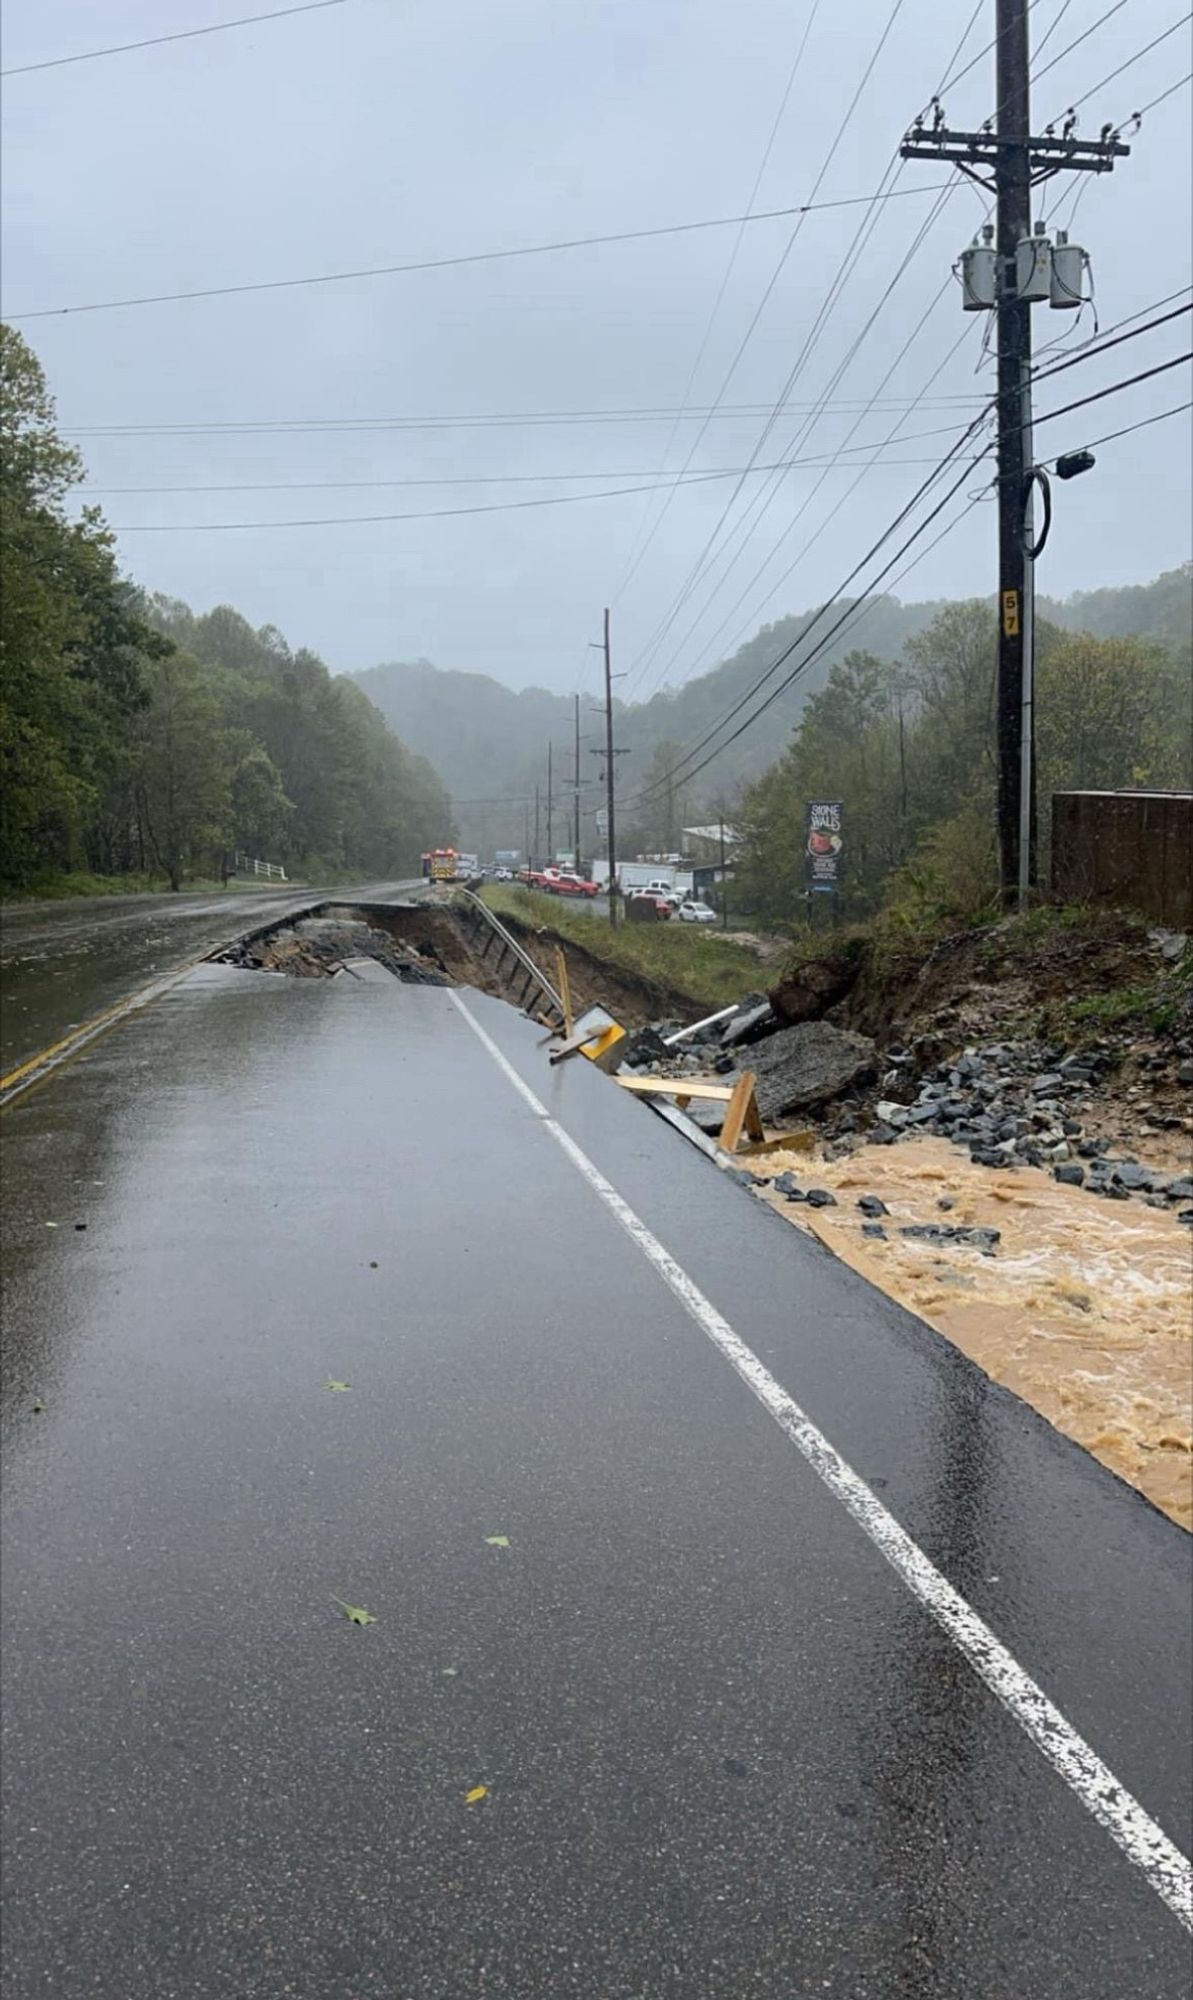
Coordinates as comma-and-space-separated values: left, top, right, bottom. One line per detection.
0, 944, 1193, 2000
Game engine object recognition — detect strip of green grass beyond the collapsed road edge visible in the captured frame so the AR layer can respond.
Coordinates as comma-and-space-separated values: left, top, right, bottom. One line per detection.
484, 884, 775, 1010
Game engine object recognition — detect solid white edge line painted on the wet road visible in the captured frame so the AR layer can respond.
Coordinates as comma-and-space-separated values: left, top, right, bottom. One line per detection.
450, 992, 1193, 1932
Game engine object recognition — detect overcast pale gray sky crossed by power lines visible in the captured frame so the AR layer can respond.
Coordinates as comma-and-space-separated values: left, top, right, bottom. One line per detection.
4, 0, 1191, 694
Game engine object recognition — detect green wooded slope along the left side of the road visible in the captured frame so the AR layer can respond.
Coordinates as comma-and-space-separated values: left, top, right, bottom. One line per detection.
0, 328, 450, 888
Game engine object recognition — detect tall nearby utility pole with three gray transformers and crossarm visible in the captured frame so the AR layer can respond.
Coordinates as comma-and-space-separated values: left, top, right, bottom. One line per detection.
899, 0, 1131, 910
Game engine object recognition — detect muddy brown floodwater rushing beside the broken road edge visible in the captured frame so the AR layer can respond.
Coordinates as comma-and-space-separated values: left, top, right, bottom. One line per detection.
753, 1138, 1193, 1528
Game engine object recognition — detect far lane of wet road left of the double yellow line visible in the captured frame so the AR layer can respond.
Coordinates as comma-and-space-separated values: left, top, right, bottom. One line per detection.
0, 884, 414, 1074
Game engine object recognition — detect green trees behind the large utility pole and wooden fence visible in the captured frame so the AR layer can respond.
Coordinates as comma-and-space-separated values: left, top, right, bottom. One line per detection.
737, 600, 1193, 924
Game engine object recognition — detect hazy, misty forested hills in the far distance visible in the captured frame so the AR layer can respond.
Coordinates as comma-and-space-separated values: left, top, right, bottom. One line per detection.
356, 568, 1193, 846
